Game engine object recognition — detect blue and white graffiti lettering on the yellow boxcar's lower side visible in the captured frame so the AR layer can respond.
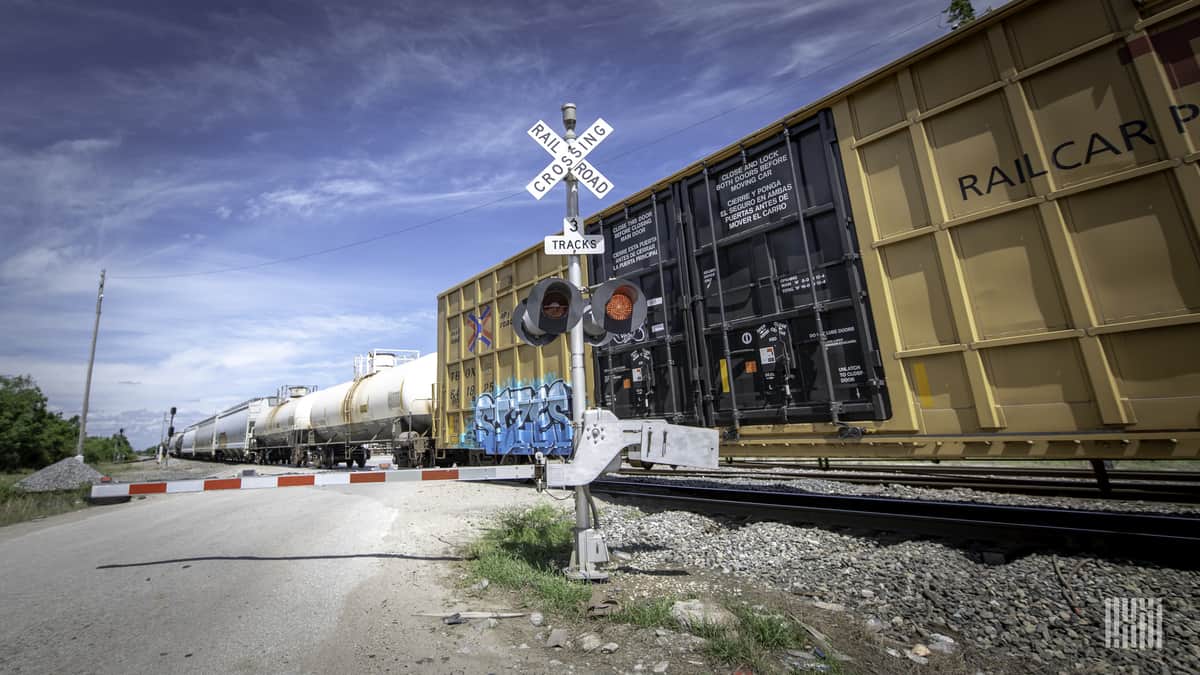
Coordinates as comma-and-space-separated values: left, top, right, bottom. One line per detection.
473, 378, 571, 455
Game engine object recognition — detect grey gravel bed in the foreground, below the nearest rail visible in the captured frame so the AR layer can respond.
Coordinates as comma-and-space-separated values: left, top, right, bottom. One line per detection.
602, 506, 1200, 673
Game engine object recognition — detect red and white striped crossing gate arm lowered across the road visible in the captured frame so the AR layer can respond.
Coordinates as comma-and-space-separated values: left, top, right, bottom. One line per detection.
91, 465, 535, 498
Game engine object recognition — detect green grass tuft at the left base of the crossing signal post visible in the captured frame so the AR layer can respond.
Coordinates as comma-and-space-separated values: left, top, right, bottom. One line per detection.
467, 504, 592, 615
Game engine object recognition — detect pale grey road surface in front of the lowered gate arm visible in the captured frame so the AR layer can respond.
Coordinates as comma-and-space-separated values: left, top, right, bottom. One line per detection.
0, 483, 545, 673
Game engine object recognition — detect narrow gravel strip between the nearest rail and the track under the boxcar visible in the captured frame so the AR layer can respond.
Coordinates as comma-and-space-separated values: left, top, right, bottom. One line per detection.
607, 473, 1200, 514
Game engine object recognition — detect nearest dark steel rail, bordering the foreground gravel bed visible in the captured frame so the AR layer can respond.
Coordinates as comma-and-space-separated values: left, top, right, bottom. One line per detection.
592, 479, 1200, 567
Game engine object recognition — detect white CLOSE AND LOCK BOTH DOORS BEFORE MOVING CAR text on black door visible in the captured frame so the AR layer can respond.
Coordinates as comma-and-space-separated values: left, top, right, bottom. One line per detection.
716, 148, 796, 232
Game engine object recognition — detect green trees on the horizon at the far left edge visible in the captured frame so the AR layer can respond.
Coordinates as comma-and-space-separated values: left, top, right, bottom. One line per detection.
0, 375, 133, 471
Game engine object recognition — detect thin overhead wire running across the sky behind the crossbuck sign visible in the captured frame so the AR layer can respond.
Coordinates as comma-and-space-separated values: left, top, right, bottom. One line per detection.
109, 13, 941, 279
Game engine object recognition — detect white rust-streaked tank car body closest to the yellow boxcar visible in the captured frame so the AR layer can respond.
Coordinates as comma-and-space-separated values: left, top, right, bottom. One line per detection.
308, 353, 438, 444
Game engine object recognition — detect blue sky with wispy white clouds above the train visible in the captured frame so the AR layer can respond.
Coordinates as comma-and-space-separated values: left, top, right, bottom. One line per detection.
0, 0, 948, 448
